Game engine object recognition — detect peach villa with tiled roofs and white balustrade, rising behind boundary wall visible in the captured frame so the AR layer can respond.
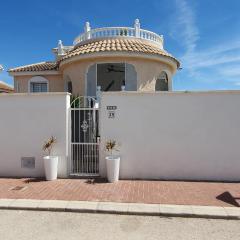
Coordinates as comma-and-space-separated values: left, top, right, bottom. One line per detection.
9, 19, 180, 96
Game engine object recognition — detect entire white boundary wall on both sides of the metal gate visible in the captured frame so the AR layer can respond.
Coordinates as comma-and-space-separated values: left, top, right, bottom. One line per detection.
0, 91, 240, 181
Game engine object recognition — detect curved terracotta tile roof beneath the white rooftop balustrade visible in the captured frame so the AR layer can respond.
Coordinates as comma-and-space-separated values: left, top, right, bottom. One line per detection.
60, 38, 180, 67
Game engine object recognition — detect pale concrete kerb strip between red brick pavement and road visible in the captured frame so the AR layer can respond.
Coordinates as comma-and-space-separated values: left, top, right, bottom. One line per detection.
0, 199, 240, 219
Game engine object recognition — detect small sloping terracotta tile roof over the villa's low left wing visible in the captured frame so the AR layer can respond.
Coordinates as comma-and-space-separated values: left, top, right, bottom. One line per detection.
8, 62, 58, 73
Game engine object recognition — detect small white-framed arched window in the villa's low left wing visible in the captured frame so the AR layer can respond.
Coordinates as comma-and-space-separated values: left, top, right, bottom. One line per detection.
28, 76, 49, 92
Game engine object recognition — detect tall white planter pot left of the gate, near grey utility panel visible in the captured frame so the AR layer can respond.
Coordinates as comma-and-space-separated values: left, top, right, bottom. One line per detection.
43, 156, 58, 181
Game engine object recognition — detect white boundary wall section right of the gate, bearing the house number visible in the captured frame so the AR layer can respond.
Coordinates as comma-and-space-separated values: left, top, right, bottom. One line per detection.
100, 91, 240, 181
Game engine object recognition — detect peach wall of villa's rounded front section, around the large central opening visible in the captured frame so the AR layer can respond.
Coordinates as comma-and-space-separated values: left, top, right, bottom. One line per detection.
61, 57, 173, 95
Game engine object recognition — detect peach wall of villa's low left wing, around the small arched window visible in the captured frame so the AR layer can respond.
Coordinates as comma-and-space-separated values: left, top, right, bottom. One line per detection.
14, 75, 65, 93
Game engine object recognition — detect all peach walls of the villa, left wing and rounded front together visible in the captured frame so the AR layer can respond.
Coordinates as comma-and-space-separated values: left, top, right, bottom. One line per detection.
14, 57, 173, 95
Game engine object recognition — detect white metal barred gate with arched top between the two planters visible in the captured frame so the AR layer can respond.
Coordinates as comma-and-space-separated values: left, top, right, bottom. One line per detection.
70, 97, 100, 176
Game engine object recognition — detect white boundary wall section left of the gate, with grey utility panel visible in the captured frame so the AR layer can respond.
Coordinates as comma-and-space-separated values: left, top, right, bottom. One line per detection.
0, 93, 70, 177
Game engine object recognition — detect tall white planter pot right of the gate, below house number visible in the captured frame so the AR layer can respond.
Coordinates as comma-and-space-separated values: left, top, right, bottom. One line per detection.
106, 156, 120, 183
